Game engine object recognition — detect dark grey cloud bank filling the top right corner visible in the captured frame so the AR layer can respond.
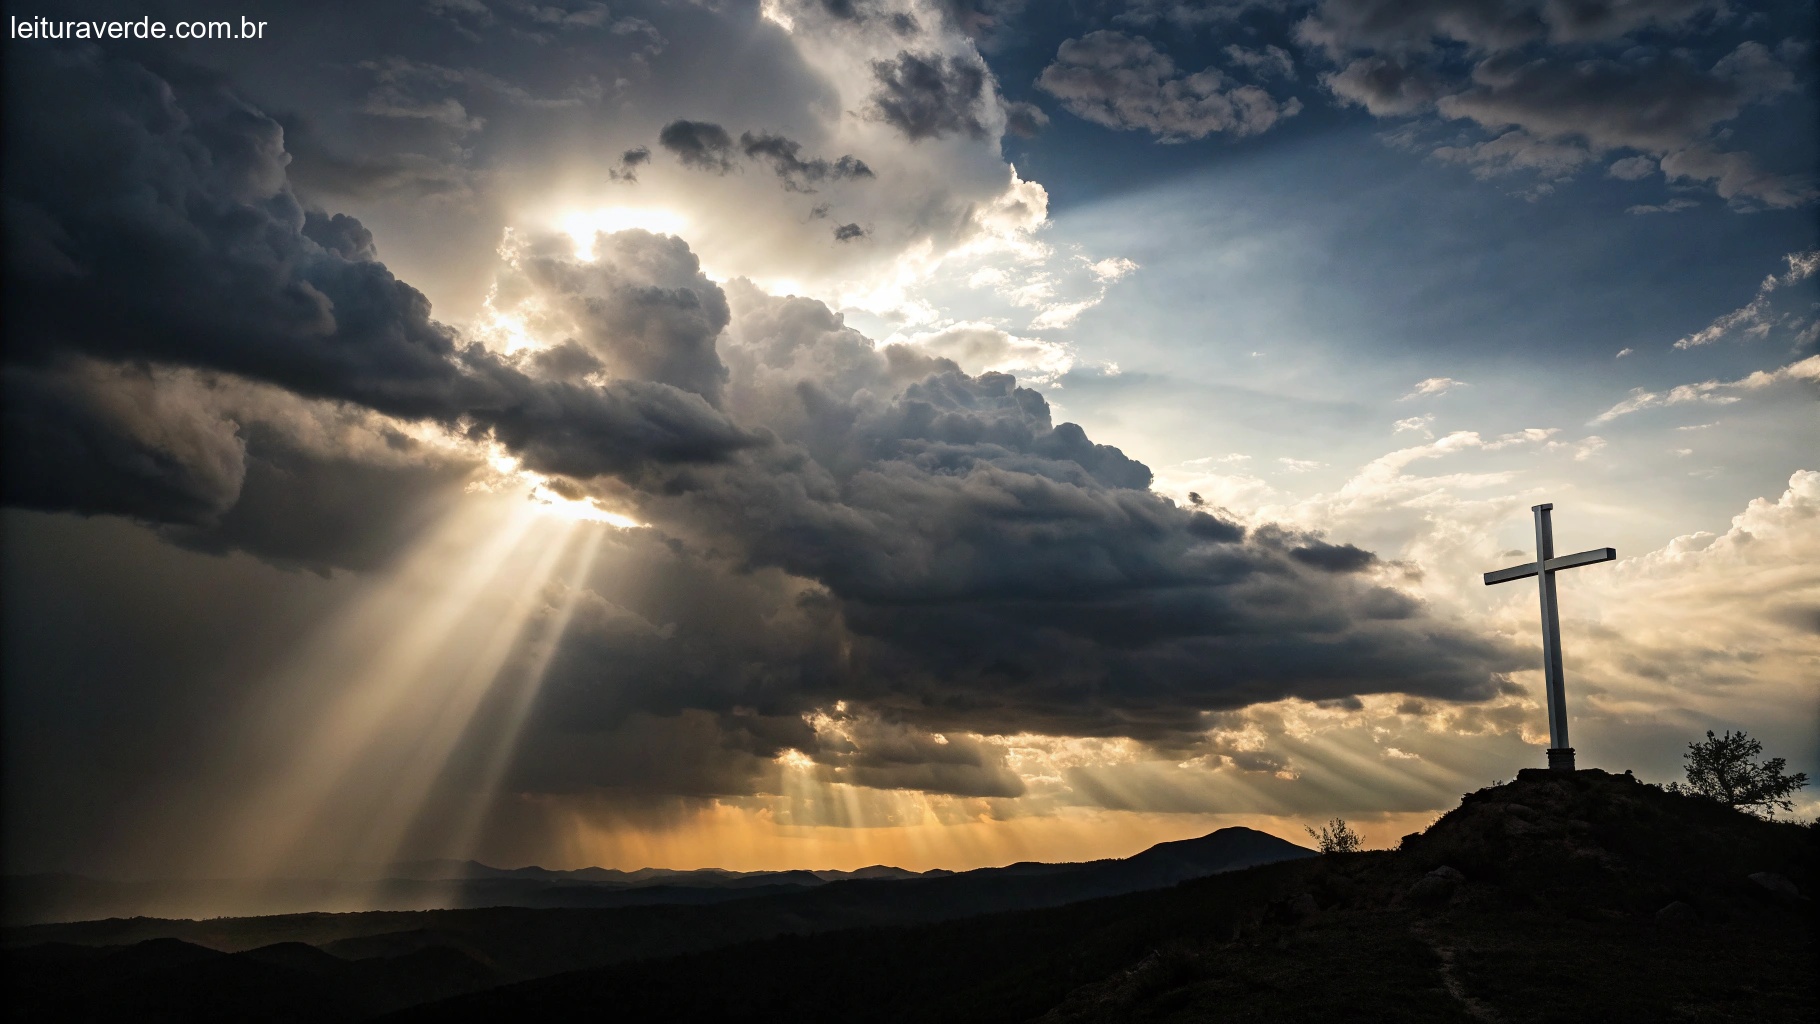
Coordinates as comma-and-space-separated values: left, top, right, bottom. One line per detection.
1296, 0, 1816, 207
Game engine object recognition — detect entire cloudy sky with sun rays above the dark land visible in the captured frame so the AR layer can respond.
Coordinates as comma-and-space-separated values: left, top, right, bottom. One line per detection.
0, 0, 1820, 878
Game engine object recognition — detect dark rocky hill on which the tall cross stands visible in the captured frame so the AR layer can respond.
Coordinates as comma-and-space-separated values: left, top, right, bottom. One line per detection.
1043, 769, 1820, 1024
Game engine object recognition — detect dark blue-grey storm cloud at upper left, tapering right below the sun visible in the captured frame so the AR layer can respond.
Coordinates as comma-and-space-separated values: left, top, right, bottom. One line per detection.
5, 47, 753, 538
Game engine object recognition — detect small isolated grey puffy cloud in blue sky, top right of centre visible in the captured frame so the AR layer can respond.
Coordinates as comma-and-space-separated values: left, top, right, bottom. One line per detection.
1037, 29, 1301, 142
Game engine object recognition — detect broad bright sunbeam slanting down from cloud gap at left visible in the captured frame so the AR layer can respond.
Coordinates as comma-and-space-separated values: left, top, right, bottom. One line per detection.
203, 495, 610, 898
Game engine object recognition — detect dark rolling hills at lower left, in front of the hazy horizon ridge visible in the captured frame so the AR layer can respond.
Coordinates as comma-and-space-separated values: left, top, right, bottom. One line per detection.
0, 828, 1314, 1022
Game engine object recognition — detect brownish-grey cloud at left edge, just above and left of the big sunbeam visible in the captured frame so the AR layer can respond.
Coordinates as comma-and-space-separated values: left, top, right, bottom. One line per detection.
4, 360, 480, 571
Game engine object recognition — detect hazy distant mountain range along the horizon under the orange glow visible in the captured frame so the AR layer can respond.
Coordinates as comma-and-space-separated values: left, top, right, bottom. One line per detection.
0, 829, 1309, 926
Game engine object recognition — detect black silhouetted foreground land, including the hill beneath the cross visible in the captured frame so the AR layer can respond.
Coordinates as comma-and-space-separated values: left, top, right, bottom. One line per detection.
7, 771, 1820, 1024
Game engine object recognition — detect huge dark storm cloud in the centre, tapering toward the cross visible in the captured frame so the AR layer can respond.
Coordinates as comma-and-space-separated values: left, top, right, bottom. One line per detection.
495, 272, 1520, 778
